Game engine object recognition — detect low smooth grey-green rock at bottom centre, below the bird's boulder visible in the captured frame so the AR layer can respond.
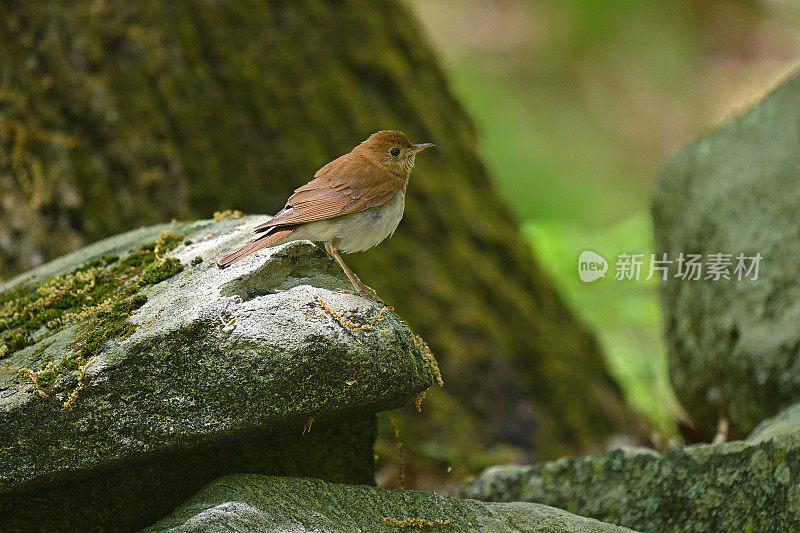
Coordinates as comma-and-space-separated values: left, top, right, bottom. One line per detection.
145, 474, 630, 533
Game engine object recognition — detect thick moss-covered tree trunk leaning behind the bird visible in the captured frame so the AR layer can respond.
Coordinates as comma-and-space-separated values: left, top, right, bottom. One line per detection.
0, 0, 624, 466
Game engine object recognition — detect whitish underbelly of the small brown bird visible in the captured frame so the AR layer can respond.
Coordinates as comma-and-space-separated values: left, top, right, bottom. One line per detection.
287, 191, 406, 253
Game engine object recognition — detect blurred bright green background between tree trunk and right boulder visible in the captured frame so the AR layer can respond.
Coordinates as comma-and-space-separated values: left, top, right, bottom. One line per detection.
406, 0, 800, 436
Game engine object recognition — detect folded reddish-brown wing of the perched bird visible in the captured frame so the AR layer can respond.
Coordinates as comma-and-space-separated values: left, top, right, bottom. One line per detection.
255, 153, 404, 233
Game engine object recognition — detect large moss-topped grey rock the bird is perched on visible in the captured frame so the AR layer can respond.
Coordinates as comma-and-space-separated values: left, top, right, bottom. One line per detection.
0, 217, 433, 531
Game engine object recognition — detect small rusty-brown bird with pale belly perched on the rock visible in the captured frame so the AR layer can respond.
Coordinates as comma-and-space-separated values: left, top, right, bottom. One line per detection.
219, 130, 435, 299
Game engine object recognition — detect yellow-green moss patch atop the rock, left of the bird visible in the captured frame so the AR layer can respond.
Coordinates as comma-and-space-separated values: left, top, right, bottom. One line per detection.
0, 232, 183, 391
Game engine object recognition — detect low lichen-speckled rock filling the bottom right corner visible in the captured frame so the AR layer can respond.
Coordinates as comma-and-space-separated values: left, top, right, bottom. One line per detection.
459, 433, 800, 532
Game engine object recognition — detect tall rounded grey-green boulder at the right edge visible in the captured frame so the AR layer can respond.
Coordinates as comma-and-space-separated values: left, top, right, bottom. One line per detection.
653, 69, 800, 440
